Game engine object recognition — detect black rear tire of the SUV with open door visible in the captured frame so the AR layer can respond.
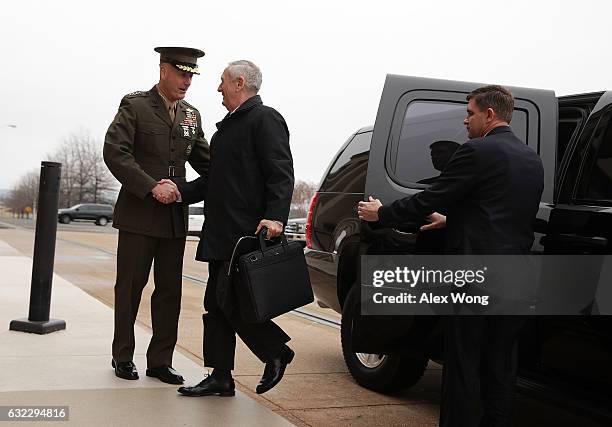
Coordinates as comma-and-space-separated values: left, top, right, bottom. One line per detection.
340, 285, 428, 392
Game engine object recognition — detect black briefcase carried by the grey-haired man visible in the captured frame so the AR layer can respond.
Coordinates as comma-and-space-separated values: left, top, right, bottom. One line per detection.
230, 232, 314, 323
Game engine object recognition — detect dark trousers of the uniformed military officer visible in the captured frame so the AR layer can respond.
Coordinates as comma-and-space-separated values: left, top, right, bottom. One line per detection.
113, 230, 185, 368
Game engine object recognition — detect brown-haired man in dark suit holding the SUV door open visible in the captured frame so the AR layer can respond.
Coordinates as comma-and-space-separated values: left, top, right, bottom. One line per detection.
358, 86, 544, 427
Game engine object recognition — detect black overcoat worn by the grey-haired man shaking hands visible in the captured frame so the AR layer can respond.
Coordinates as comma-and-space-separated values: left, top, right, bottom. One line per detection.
179, 95, 294, 261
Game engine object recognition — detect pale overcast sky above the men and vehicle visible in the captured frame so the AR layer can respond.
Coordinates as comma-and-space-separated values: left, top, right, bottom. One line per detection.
0, 0, 612, 189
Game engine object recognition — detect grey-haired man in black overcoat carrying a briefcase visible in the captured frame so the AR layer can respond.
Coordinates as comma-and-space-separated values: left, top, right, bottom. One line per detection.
170, 61, 294, 396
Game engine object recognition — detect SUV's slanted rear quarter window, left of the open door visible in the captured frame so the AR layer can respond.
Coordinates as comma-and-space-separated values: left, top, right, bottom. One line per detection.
321, 132, 372, 193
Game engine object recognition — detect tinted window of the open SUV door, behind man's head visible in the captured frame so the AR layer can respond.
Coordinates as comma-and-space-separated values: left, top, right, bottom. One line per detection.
390, 101, 527, 184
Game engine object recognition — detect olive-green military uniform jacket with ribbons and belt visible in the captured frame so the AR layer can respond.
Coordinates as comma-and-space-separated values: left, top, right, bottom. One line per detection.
104, 86, 210, 238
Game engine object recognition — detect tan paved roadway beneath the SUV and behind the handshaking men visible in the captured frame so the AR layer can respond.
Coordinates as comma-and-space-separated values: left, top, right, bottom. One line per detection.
0, 224, 603, 426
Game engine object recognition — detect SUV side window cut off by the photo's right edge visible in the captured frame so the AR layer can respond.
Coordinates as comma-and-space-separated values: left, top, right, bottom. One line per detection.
576, 109, 612, 205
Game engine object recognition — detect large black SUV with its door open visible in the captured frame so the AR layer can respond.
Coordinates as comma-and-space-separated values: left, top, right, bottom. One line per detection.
305, 75, 612, 411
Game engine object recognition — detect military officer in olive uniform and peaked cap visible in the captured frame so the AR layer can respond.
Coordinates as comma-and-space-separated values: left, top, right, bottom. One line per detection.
104, 47, 210, 384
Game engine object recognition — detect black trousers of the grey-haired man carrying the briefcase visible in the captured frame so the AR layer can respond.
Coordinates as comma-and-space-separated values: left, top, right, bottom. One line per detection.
202, 261, 291, 370
